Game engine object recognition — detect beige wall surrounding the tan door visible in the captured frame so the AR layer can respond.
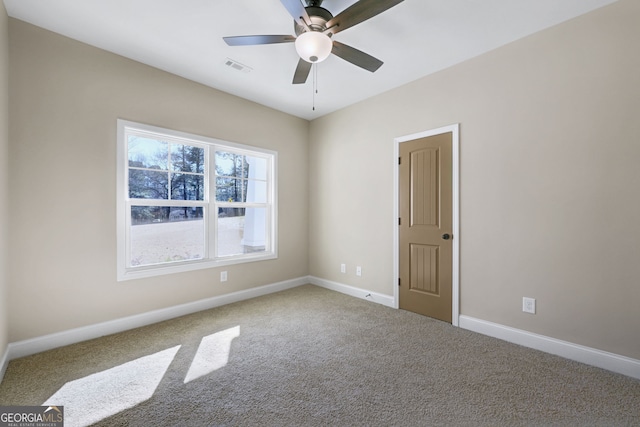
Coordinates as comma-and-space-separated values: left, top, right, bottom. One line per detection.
310, 0, 640, 359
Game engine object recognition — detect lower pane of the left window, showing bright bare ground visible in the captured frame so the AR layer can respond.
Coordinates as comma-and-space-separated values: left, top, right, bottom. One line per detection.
129, 206, 205, 267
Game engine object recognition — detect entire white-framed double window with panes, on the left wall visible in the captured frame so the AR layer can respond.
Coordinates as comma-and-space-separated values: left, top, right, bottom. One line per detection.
117, 120, 277, 280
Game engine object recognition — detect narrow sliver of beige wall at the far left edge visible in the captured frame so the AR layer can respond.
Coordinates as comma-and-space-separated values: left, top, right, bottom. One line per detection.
0, 2, 9, 358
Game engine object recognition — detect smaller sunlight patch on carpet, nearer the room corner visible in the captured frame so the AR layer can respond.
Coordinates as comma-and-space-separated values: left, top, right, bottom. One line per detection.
184, 326, 240, 384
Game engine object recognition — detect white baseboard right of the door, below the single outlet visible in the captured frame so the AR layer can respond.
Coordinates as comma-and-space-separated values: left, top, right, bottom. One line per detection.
460, 316, 640, 379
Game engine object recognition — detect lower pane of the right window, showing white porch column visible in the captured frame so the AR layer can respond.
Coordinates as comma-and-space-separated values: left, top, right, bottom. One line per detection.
217, 208, 267, 257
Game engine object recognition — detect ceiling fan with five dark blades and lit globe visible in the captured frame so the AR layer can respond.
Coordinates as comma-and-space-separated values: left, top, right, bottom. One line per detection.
223, 0, 404, 84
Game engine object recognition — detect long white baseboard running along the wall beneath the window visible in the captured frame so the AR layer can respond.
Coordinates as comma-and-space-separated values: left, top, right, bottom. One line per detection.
6, 276, 309, 362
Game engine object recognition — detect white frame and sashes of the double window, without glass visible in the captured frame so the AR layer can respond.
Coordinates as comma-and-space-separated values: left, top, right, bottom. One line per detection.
116, 119, 278, 281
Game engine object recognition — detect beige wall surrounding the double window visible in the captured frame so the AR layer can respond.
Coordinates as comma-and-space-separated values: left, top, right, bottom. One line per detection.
9, 19, 309, 342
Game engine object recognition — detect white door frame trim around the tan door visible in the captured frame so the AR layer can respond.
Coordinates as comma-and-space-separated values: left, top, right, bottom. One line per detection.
393, 123, 460, 326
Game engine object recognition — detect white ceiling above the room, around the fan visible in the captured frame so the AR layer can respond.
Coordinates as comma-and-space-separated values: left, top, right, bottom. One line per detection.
4, 0, 616, 120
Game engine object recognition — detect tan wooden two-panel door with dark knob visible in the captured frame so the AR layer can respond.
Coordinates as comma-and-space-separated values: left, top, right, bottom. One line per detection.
399, 132, 456, 323
